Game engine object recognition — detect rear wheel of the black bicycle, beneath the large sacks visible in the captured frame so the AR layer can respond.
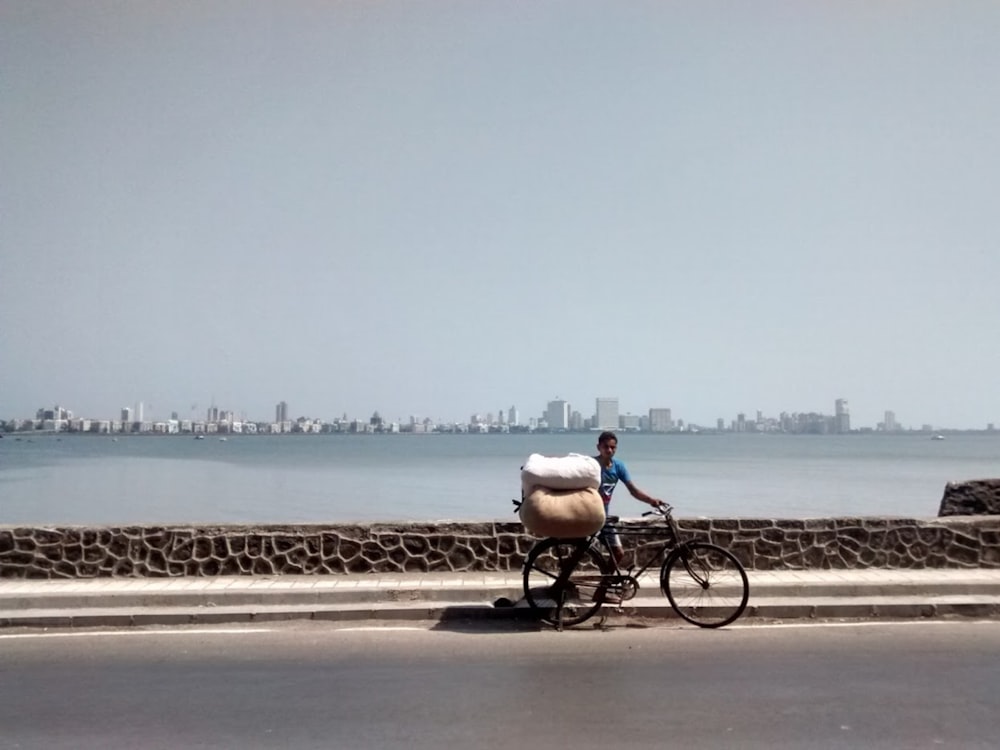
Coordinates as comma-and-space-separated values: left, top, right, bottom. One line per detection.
524, 539, 612, 627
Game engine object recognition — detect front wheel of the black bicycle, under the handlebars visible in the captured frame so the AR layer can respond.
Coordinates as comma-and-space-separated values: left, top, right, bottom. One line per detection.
660, 542, 750, 628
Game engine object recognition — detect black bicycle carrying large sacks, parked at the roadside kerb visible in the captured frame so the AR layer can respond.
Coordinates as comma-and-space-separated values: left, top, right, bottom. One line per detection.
514, 500, 750, 630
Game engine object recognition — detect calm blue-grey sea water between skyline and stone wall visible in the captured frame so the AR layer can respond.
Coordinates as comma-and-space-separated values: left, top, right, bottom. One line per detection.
0, 433, 1000, 525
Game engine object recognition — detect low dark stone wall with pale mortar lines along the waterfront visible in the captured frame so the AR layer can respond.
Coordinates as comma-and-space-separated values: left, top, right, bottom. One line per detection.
0, 516, 1000, 578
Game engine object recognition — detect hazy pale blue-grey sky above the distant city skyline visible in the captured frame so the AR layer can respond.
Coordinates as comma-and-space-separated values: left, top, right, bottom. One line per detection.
0, 0, 1000, 428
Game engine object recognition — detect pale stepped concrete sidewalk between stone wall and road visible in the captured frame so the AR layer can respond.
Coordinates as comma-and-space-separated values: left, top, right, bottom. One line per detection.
0, 568, 1000, 628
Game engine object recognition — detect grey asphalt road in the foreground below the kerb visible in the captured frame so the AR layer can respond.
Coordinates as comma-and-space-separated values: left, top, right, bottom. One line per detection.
0, 621, 1000, 750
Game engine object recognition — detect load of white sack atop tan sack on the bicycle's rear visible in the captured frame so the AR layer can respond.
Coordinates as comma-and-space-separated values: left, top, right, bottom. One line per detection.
518, 453, 604, 539
